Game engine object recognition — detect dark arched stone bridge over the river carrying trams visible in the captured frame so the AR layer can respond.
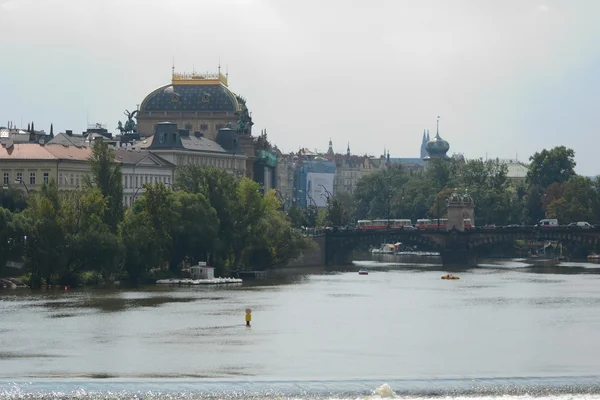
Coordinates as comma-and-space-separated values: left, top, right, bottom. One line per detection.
325, 226, 600, 266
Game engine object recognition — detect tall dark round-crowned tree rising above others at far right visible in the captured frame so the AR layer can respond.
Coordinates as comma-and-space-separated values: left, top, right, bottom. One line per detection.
527, 146, 576, 188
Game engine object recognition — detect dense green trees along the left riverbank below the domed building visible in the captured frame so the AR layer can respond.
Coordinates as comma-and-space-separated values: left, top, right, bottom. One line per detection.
0, 142, 314, 288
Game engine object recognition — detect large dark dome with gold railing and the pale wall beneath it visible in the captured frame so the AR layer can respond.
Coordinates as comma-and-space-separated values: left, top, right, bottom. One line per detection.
137, 67, 253, 140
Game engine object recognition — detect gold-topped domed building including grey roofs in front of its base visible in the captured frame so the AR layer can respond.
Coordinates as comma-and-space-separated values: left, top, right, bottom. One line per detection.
136, 67, 268, 183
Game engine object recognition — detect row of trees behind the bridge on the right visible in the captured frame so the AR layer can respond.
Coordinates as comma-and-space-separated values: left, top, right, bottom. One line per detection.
289, 146, 600, 226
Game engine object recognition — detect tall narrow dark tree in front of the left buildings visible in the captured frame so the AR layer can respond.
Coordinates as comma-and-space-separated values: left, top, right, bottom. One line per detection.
85, 140, 124, 232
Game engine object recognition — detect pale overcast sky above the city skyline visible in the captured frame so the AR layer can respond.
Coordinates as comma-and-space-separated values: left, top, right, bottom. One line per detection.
0, 0, 600, 175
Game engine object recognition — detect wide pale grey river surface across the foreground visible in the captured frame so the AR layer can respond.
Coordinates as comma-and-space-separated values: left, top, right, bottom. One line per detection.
0, 261, 600, 399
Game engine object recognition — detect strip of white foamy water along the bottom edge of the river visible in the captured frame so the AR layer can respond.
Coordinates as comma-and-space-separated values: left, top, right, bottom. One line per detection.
0, 379, 600, 400
